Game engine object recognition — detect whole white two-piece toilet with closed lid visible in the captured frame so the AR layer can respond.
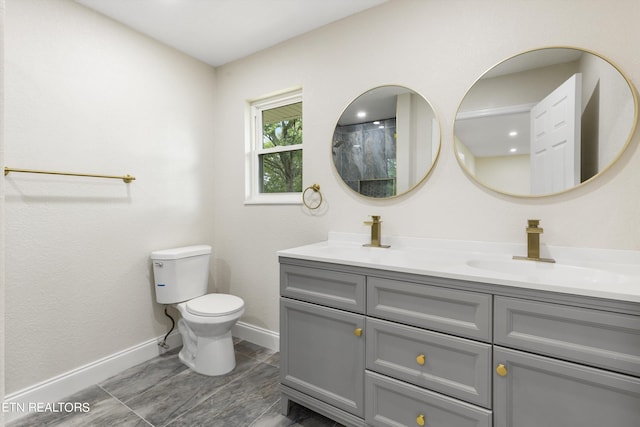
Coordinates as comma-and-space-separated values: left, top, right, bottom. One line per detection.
151, 245, 244, 376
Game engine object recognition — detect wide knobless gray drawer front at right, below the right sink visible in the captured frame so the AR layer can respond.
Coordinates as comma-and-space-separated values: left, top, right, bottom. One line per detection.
494, 297, 640, 375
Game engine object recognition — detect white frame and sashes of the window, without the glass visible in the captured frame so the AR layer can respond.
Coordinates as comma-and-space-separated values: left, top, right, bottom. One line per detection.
244, 88, 304, 205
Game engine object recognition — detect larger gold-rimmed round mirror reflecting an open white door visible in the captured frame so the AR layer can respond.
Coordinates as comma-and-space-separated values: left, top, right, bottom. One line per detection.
455, 48, 638, 196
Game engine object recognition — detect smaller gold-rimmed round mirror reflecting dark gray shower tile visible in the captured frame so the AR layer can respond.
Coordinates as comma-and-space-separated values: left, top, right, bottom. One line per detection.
331, 86, 440, 198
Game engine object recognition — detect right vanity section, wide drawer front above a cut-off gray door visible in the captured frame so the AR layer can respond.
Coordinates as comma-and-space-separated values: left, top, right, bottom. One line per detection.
493, 296, 640, 427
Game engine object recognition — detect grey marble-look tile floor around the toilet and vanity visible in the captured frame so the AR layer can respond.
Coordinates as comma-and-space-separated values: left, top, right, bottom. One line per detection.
7, 341, 340, 427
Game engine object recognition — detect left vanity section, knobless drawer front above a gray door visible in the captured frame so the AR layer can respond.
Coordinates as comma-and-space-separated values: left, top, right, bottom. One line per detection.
280, 264, 365, 426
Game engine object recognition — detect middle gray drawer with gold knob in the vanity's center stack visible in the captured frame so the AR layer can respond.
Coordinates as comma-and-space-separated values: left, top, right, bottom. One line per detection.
366, 318, 492, 408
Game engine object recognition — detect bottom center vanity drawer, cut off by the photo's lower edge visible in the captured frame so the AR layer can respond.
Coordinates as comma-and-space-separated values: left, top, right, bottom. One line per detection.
365, 371, 492, 427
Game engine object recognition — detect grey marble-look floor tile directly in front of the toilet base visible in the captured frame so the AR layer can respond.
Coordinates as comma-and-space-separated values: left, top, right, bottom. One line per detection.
127, 354, 259, 426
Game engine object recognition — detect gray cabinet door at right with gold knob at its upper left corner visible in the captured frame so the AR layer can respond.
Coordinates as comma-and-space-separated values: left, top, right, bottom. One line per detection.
493, 346, 640, 427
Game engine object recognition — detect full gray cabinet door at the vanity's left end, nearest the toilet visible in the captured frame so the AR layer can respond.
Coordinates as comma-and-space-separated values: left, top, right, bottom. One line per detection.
280, 298, 365, 417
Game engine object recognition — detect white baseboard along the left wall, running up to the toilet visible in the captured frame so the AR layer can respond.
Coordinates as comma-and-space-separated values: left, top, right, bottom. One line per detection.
3, 331, 182, 423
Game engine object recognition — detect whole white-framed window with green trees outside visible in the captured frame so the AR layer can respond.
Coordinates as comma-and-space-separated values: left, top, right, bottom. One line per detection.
245, 91, 302, 204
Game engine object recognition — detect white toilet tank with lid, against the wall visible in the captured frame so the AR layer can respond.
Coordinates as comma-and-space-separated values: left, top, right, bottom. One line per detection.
151, 245, 211, 304
